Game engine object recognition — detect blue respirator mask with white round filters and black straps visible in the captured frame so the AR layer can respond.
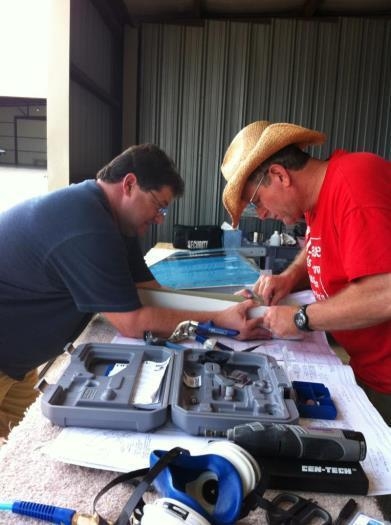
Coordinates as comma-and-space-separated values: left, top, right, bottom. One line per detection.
89, 441, 268, 525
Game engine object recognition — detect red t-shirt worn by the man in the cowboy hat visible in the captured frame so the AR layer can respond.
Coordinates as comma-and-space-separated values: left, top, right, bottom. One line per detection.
305, 151, 391, 394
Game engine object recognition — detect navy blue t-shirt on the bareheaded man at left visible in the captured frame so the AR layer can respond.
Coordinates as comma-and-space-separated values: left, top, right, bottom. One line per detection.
0, 180, 153, 379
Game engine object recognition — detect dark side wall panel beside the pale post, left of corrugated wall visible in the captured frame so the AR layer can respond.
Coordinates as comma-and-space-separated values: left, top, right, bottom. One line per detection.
69, 0, 123, 182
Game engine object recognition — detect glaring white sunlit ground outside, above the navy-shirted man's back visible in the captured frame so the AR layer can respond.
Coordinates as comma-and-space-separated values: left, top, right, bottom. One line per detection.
0, 166, 48, 212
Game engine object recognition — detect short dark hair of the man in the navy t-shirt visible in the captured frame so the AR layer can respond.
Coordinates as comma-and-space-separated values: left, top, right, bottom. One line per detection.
96, 144, 185, 197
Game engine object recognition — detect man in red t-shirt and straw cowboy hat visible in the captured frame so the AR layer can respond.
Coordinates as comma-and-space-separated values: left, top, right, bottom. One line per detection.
221, 121, 391, 425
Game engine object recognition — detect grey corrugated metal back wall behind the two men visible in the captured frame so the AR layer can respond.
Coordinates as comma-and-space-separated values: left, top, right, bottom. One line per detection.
133, 18, 391, 248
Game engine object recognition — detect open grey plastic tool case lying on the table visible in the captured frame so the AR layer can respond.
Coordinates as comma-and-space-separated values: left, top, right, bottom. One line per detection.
38, 343, 299, 435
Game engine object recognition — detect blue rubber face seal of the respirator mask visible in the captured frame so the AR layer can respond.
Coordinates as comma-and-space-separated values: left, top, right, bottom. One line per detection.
150, 450, 243, 525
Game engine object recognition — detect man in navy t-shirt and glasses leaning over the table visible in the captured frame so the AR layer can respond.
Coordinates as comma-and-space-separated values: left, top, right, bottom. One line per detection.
0, 144, 263, 436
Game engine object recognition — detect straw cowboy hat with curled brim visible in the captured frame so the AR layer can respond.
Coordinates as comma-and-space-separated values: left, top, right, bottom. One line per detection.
221, 120, 326, 228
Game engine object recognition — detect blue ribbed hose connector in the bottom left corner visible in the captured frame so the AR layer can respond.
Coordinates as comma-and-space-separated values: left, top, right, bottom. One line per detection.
0, 501, 76, 525
